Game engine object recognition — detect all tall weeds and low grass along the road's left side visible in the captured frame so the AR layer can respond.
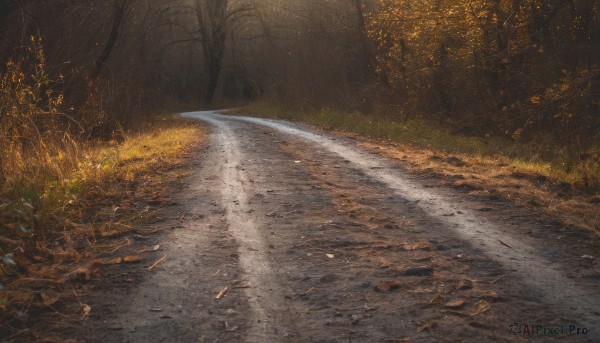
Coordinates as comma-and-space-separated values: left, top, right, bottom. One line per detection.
0, 38, 203, 338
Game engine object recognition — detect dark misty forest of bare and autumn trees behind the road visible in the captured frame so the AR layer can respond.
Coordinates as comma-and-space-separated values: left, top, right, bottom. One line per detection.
0, 0, 600, 138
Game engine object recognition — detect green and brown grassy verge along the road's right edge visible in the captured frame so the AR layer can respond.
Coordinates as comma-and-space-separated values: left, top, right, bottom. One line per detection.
233, 103, 600, 233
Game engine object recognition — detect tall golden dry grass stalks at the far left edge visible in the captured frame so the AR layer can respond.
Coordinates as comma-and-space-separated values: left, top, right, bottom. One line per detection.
0, 38, 82, 255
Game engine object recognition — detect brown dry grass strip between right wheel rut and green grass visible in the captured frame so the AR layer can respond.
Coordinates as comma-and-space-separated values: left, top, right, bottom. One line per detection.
361, 141, 600, 234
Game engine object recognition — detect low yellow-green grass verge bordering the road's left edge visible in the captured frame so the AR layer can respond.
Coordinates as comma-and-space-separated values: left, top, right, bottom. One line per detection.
0, 115, 204, 341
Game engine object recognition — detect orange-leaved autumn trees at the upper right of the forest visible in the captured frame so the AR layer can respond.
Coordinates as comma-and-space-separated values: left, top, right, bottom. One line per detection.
368, 0, 600, 147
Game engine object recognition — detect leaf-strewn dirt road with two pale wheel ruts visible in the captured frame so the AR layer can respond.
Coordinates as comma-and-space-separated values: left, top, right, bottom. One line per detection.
81, 112, 600, 342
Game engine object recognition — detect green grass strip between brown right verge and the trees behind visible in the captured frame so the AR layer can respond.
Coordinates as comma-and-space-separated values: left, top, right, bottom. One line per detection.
233, 102, 600, 192
